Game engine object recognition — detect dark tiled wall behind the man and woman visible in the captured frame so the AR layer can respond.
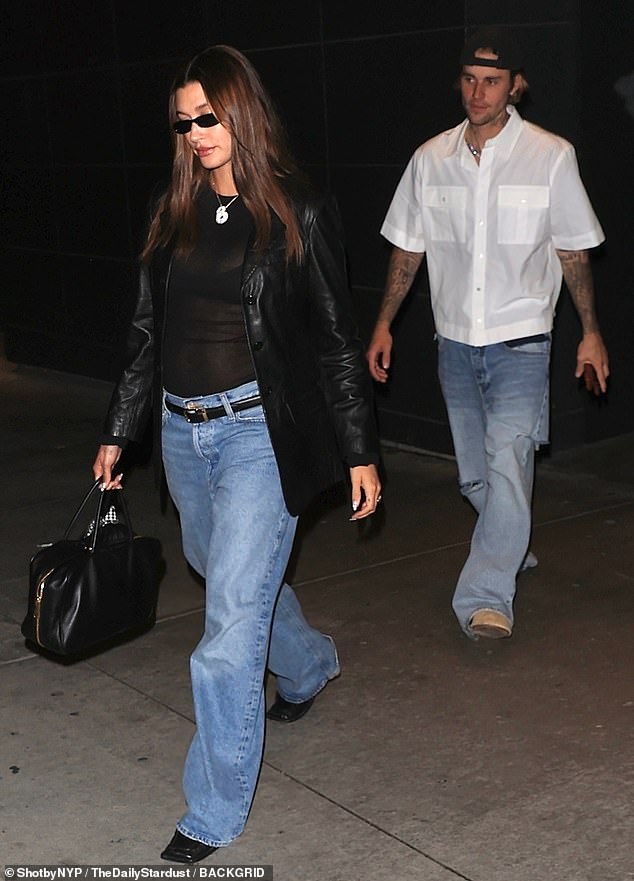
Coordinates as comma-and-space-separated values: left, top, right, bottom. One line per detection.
0, 0, 634, 452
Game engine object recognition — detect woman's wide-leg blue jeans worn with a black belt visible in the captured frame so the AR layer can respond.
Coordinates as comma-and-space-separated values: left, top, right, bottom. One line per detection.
162, 382, 339, 846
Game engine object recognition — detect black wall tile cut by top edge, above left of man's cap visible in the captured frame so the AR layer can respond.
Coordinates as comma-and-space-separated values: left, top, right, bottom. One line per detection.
323, 0, 464, 40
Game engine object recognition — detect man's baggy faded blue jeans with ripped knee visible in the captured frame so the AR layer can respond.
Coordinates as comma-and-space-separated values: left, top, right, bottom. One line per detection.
438, 334, 550, 636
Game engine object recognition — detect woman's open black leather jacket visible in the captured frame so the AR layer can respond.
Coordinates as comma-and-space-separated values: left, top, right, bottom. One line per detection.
104, 186, 379, 514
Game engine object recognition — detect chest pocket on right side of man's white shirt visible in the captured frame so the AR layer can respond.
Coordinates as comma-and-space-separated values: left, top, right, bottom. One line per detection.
498, 186, 550, 245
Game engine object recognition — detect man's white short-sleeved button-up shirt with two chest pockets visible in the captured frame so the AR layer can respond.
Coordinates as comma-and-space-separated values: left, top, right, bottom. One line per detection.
381, 106, 604, 346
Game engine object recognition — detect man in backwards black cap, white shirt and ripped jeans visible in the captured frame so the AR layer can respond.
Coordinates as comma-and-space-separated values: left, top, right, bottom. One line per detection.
368, 28, 609, 639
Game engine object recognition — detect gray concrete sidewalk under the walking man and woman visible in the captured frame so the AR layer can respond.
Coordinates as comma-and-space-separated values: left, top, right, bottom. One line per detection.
0, 352, 634, 881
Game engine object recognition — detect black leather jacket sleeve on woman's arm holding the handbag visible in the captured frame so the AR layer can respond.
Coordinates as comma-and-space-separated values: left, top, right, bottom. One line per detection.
103, 265, 154, 446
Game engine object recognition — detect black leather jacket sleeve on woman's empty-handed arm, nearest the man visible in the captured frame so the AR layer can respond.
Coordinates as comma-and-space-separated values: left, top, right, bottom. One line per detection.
306, 198, 379, 465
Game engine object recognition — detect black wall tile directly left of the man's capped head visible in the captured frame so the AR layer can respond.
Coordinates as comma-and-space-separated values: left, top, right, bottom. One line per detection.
326, 30, 463, 164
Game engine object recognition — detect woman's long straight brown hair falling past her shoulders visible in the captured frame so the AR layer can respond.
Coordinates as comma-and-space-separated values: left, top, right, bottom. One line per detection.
141, 45, 303, 262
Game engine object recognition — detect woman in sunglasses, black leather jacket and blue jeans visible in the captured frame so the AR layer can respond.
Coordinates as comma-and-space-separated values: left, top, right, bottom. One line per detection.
93, 46, 380, 863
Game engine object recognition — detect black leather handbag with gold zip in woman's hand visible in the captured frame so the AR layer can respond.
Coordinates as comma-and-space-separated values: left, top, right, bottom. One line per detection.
22, 480, 161, 656
